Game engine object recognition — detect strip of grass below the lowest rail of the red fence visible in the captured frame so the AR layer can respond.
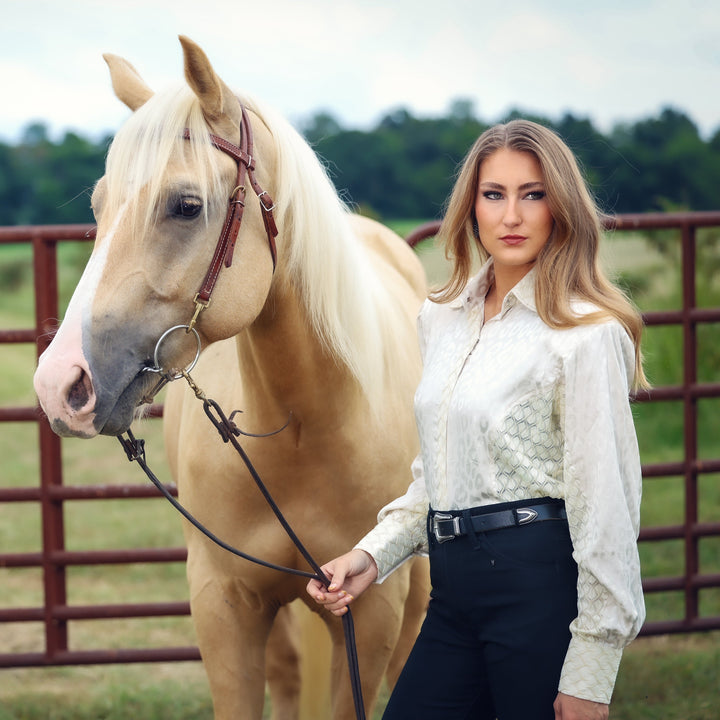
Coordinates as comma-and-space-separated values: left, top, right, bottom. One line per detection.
0, 633, 720, 720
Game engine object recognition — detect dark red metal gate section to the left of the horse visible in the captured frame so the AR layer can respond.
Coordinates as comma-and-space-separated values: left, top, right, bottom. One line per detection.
0, 225, 194, 668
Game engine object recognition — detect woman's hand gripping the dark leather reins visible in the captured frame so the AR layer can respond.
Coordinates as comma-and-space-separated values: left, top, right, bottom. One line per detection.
307, 550, 378, 616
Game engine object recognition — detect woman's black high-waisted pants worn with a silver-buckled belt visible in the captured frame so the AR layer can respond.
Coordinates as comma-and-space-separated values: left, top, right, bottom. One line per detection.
383, 502, 577, 720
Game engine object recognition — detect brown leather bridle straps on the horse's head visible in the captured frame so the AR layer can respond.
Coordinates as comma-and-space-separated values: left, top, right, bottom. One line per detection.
183, 104, 277, 332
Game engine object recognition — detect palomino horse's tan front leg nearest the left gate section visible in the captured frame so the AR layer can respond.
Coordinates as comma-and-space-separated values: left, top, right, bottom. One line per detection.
188, 563, 273, 720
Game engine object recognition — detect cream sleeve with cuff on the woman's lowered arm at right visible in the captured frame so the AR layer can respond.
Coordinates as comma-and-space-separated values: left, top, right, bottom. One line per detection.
560, 322, 645, 703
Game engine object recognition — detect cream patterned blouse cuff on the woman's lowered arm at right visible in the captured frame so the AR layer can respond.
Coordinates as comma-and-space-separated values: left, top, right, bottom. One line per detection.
559, 636, 622, 704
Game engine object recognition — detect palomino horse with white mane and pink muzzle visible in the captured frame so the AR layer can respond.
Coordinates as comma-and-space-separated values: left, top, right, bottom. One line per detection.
35, 38, 428, 720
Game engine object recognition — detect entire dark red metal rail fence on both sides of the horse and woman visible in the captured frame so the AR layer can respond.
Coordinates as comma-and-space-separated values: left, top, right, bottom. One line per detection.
0, 212, 720, 668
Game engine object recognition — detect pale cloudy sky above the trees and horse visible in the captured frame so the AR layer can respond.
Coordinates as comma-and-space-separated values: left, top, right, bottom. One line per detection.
0, 0, 720, 143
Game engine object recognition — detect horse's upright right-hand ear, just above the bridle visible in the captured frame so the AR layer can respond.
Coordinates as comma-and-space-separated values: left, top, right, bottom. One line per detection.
179, 35, 240, 133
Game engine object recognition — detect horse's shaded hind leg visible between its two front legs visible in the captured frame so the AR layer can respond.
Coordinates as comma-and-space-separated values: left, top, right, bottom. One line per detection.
265, 604, 302, 720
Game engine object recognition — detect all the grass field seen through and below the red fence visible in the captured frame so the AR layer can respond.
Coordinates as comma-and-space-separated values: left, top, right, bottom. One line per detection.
0, 223, 720, 720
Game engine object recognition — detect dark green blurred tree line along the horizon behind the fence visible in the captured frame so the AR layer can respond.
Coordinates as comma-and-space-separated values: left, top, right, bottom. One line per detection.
0, 100, 720, 225
